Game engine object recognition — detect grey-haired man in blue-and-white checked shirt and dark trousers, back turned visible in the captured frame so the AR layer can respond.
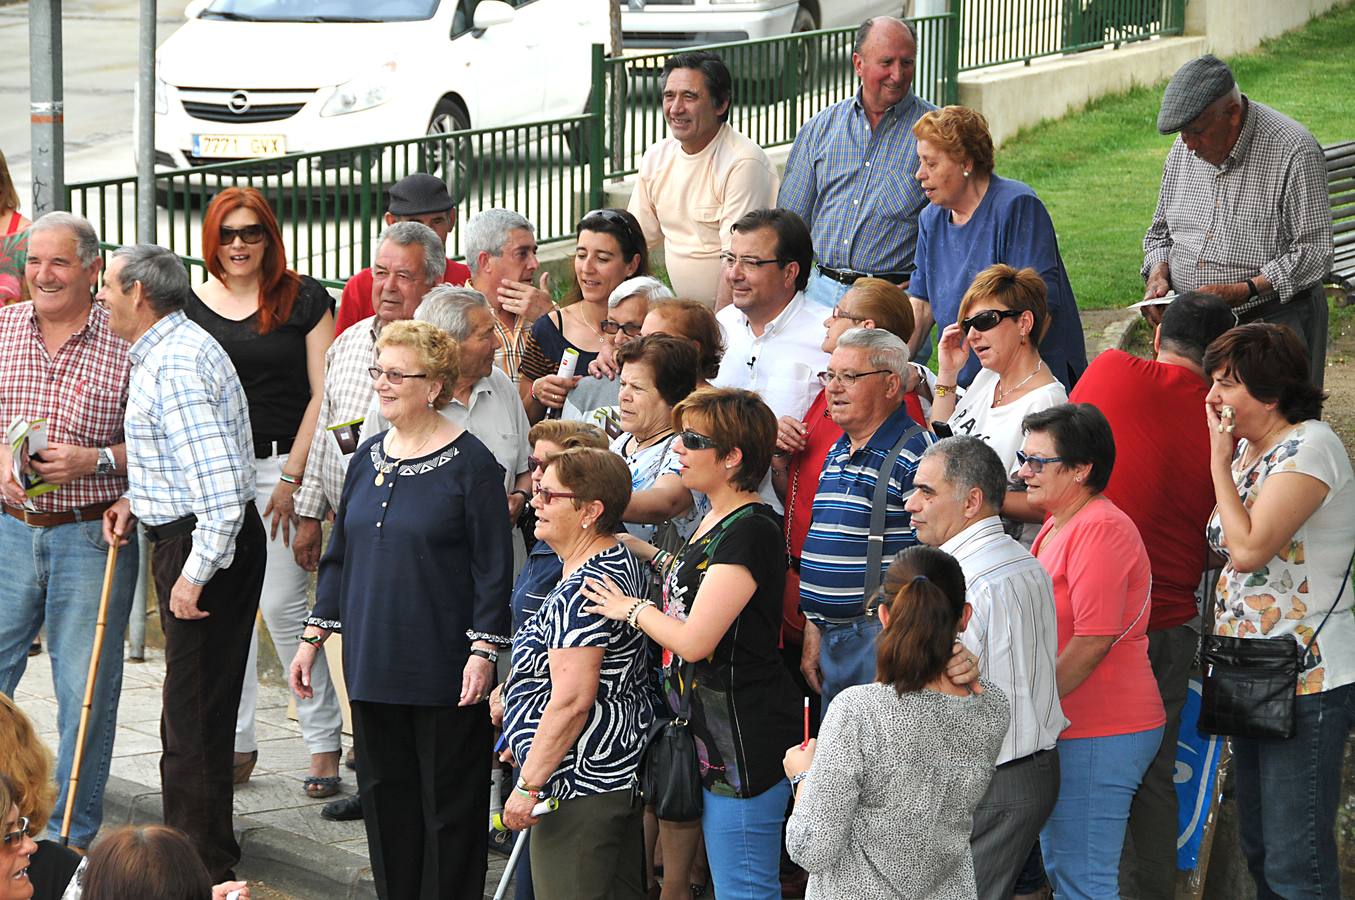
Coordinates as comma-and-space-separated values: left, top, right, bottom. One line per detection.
99, 244, 266, 882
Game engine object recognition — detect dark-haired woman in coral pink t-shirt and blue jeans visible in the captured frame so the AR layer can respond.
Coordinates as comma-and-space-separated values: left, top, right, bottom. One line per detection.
1016, 403, 1167, 900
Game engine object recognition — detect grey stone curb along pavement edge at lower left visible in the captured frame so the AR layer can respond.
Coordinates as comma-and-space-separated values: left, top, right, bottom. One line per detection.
103, 775, 377, 900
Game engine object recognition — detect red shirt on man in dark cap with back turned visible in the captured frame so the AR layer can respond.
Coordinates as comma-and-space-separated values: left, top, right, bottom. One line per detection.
1069, 350, 1214, 632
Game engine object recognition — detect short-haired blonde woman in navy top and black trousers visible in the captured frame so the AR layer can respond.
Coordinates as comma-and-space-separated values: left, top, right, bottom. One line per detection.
289, 321, 512, 897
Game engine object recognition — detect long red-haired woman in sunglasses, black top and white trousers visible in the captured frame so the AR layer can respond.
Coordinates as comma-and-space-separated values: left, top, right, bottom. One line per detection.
184, 187, 343, 798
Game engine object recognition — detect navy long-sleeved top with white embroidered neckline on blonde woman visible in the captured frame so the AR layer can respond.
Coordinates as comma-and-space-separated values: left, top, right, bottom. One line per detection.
306, 431, 512, 706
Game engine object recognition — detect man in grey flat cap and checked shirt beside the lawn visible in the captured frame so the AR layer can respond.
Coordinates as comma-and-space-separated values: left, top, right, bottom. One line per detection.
1142, 56, 1332, 388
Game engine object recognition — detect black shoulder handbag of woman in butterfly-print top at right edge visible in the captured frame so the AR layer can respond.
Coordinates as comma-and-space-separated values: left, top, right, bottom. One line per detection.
1199, 547, 1351, 740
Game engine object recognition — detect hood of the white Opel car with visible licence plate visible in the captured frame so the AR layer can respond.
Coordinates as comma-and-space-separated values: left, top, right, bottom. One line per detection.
157, 19, 428, 88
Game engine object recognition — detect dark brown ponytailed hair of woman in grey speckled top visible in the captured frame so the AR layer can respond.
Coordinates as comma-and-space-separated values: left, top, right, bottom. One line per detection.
875, 546, 965, 695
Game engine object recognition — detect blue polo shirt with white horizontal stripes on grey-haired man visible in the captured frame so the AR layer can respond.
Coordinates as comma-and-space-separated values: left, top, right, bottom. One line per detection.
799, 407, 936, 618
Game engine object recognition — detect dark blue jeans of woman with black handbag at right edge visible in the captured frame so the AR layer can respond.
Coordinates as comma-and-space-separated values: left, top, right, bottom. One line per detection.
1232, 684, 1355, 900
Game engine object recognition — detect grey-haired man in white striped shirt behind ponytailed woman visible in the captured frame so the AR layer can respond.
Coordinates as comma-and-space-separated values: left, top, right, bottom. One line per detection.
905, 436, 1068, 900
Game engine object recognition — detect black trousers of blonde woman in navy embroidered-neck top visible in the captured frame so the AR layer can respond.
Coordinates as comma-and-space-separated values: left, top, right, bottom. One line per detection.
352, 701, 493, 900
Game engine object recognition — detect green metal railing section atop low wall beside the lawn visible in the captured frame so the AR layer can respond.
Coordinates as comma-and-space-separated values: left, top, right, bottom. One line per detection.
951, 0, 1186, 72
